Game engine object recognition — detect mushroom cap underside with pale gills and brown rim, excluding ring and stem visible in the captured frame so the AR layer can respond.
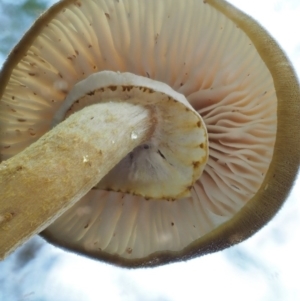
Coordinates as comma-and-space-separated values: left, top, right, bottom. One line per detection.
0, 0, 300, 266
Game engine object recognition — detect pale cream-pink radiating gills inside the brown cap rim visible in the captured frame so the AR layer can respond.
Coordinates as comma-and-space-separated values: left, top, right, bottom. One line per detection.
0, 0, 277, 258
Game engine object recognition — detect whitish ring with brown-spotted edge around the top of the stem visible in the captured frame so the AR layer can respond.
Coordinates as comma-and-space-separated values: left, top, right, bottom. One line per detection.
53, 71, 208, 200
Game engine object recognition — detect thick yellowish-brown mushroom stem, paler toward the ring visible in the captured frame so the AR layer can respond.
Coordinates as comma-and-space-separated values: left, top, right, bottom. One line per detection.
0, 102, 156, 259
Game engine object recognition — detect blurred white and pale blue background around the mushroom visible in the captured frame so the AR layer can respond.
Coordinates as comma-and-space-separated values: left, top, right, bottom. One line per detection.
0, 0, 300, 301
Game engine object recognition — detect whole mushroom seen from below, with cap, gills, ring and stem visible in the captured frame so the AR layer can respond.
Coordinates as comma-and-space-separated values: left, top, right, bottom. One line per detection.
0, 0, 300, 267
